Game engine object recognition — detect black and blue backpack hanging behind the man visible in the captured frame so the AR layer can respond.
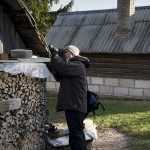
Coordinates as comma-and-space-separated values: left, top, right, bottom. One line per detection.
87, 89, 105, 115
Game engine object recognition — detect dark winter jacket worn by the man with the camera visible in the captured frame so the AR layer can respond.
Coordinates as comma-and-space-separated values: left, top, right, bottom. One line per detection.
52, 55, 90, 113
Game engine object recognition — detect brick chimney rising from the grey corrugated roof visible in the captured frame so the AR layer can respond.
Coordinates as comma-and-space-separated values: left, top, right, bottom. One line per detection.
116, 0, 135, 39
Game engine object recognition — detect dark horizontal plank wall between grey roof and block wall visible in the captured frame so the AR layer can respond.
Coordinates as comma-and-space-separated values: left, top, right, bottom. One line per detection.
83, 54, 150, 79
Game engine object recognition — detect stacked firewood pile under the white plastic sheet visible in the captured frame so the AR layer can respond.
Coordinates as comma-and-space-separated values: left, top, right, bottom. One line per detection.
0, 72, 47, 150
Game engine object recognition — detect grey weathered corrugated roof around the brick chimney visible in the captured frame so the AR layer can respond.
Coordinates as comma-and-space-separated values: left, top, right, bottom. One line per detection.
45, 6, 150, 54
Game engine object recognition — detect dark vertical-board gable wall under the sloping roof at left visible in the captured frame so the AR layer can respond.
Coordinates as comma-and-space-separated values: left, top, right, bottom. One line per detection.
0, 3, 25, 54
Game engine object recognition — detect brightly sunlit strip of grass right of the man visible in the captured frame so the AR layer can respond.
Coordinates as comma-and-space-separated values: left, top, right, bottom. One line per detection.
91, 111, 150, 137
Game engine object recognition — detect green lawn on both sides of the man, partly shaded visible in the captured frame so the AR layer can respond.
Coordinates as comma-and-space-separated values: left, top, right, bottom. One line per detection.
49, 97, 150, 150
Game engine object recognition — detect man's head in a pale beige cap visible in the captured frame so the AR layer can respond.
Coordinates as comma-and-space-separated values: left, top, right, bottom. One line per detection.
64, 45, 80, 60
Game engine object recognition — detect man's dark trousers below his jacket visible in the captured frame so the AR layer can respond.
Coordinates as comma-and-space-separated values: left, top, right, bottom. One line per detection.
65, 110, 87, 150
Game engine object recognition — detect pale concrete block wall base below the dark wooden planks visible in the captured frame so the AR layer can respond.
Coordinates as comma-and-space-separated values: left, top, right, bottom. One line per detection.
46, 77, 150, 100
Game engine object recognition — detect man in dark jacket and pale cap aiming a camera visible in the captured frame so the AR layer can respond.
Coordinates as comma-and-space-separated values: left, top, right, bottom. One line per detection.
51, 45, 90, 150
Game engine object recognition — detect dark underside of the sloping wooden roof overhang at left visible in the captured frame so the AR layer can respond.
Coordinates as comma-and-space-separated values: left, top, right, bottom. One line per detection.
0, 0, 49, 57
